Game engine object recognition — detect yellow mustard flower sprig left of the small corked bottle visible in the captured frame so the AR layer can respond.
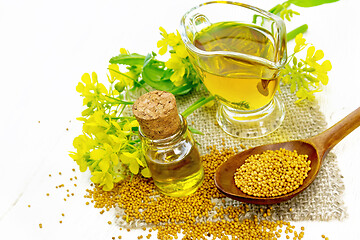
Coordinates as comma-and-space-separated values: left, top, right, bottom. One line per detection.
69, 66, 208, 191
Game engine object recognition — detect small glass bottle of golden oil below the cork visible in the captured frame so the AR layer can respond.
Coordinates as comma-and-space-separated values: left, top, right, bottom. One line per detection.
139, 115, 204, 197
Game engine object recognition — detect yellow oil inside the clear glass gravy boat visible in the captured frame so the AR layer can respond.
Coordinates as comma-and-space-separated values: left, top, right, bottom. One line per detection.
192, 22, 279, 110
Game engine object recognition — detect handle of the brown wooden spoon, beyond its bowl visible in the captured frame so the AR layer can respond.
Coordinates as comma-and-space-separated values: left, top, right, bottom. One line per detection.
308, 107, 360, 157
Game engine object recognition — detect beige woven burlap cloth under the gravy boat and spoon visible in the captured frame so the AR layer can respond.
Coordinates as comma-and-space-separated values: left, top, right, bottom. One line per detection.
116, 86, 347, 227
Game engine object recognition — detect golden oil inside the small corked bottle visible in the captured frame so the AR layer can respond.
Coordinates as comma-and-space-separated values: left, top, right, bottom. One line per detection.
146, 144, 204, 197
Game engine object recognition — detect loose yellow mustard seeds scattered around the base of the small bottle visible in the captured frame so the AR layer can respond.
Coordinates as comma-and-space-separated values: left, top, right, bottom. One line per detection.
84, 147, 312, 240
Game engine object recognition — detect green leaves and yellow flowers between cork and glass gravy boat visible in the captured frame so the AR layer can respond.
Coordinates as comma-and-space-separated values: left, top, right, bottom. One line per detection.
110, 27, 201, 95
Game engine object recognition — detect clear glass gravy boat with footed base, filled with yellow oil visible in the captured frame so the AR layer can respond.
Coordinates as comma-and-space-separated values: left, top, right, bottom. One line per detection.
180, 1, 287, 138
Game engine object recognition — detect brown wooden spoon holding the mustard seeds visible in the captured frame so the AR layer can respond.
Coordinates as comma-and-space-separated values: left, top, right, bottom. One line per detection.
215, 107, 360, 205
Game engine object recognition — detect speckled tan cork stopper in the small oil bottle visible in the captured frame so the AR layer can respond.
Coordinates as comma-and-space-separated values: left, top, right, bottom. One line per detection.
132, 91, 181, 139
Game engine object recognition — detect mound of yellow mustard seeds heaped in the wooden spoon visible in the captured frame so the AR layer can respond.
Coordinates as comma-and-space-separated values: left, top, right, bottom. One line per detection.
234, 149, 311, 197
